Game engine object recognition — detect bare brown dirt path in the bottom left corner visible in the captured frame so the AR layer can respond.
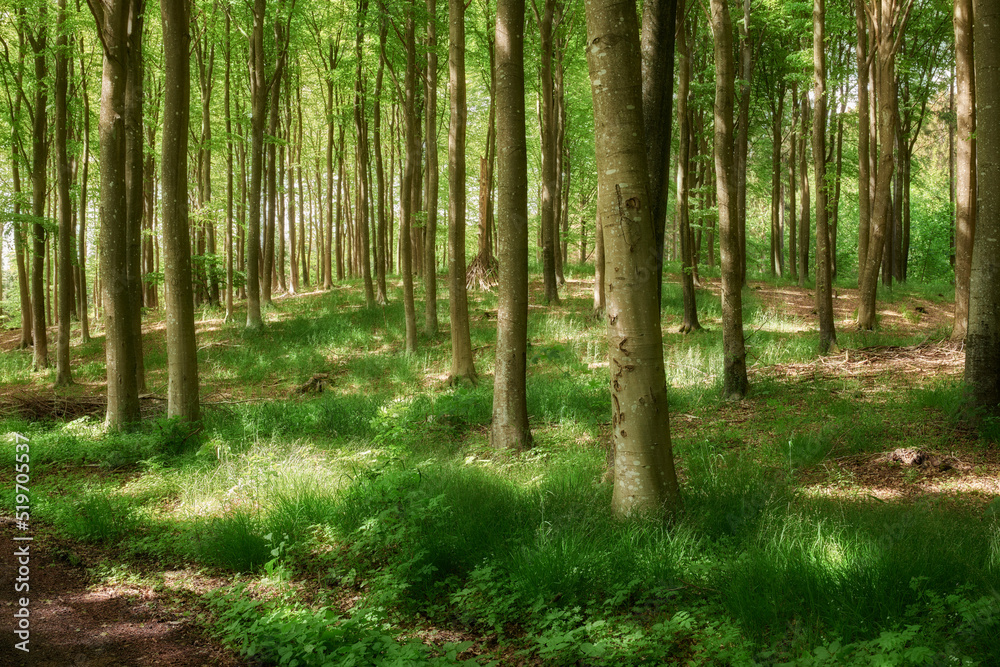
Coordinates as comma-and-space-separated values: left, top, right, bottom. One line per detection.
0, 517, 251, 667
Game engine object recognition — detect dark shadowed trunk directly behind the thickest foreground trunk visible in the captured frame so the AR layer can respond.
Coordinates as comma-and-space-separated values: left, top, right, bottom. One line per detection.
640, 0, 690, 304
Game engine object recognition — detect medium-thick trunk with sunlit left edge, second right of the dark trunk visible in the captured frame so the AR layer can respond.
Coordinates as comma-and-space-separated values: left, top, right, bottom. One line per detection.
711, 0, 749, 399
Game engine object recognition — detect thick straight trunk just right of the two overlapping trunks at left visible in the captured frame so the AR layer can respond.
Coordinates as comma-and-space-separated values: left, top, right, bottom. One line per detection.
160, 0, 198, 422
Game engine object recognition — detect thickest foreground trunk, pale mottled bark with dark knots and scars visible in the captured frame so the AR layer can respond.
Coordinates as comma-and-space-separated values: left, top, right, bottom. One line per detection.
586, 0, 681, 515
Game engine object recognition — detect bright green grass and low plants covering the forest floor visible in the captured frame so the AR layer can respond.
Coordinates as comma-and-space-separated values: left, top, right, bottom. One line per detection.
0, 274, 1000, 665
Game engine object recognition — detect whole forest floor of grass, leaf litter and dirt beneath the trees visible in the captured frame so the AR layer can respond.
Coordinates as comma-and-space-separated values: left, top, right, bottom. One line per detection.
0, 268, 1000, 667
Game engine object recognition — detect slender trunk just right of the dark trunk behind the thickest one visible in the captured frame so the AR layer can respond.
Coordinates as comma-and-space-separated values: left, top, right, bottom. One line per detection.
676, 0, 701, 333
